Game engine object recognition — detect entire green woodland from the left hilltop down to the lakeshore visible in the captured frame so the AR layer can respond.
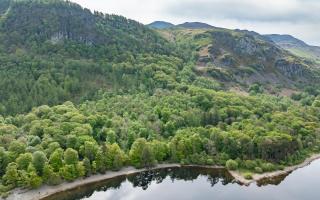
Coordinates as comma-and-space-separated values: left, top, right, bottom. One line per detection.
0, 0, 320, 195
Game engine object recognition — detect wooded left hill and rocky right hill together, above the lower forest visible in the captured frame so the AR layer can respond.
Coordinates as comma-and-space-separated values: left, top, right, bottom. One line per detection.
0, 0, 318, 115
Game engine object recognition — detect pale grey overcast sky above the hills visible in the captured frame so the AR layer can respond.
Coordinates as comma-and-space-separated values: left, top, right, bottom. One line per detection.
72, 0, 320, 46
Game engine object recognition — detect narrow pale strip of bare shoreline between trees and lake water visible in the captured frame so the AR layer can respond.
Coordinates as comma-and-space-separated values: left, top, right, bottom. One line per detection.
0, 154, 320, 200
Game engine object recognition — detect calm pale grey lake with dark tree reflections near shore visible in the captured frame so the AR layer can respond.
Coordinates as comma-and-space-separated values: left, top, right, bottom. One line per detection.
46, 160, 320, 200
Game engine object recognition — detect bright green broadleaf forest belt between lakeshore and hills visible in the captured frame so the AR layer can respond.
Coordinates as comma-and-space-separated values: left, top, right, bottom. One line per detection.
0, 86, 320, 195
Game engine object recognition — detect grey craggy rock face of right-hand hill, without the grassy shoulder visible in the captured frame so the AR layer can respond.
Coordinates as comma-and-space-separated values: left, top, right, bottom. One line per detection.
190, 29, 315, 84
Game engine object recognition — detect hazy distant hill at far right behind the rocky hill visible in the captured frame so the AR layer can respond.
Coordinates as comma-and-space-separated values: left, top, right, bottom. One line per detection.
265, 34, 320, 64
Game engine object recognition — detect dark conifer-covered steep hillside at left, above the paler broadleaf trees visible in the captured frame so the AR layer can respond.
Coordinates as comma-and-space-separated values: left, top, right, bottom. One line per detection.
0, 0, 181, 115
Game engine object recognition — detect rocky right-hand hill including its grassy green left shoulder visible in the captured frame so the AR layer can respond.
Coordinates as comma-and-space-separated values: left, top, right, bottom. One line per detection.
160, 28, 319, 92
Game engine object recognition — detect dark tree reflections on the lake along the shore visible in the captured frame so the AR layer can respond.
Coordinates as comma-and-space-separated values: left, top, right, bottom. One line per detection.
42, 167, 287, 200
